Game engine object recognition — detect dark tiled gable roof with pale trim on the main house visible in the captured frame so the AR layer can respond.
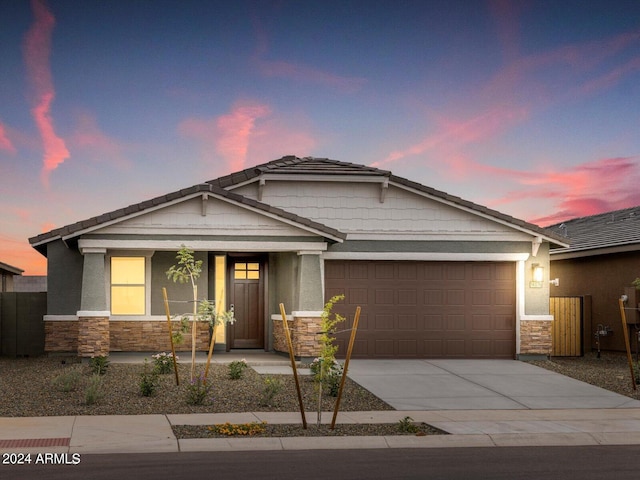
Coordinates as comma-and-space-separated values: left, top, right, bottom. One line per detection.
29, 156, 568, 255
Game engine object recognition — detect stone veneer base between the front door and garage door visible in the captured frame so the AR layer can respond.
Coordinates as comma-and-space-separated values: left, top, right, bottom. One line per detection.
273, 317, 321, 358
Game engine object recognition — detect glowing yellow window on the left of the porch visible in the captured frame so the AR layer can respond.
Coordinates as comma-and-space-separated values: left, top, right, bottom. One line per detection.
111, 257, 145, 315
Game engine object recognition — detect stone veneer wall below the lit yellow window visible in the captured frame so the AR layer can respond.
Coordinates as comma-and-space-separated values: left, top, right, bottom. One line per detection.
110, 320, 210, 352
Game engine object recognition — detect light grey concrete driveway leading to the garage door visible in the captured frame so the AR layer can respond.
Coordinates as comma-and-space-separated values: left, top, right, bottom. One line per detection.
348, 360, 640, 410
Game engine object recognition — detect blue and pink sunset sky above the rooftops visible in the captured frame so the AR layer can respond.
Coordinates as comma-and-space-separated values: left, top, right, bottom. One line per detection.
0, 0, 640, 275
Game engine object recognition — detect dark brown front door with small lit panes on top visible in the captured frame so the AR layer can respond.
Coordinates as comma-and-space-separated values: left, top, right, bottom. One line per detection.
227, 257, 264, 348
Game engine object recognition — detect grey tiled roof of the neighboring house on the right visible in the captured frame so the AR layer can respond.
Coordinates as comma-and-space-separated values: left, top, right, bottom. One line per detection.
547, 206, 640, 260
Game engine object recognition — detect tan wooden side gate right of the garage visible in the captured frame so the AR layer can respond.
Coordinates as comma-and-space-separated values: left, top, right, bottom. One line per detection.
549, 297, 584, 357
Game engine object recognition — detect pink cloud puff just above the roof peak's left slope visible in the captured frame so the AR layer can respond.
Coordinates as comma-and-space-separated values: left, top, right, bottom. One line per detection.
178, 102, 315, 171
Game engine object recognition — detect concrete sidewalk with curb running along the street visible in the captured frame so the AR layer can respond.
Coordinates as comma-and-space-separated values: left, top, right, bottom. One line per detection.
0, 409, 640, 454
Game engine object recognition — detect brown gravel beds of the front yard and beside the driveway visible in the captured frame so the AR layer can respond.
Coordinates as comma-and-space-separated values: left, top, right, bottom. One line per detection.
0, 353, 640, 438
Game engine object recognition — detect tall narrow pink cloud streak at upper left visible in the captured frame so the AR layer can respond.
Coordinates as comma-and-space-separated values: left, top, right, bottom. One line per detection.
24, 0, 69, 186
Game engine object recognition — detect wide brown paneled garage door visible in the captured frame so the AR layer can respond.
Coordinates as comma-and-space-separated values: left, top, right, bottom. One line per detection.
325, 260, 516, 358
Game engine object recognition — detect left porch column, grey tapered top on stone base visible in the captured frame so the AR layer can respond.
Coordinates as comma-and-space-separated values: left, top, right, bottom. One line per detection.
78, 248, 110, 357
